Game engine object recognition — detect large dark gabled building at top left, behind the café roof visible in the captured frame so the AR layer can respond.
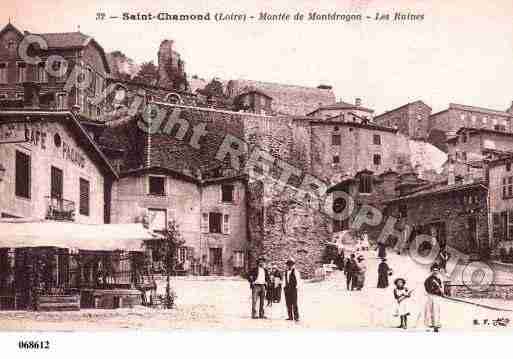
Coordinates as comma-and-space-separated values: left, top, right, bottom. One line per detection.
0, 23, 110, 120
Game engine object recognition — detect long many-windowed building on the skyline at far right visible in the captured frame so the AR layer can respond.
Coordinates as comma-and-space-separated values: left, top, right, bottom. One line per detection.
428, 103, 513, 152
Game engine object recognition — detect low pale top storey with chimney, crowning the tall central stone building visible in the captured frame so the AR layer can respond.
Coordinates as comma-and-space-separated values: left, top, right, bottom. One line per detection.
307, 98, 374, 122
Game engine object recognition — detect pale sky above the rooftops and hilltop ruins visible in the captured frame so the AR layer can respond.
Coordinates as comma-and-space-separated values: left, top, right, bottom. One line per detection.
0, 0, 513, 113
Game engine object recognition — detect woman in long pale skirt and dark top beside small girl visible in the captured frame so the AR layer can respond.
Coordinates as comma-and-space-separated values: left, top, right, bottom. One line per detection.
424, 263, 444, 333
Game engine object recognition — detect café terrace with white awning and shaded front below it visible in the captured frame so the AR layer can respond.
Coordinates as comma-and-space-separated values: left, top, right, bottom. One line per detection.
0, 221, 159, 310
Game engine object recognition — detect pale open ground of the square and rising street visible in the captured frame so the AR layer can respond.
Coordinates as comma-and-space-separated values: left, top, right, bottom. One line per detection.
0, 252, 513, 331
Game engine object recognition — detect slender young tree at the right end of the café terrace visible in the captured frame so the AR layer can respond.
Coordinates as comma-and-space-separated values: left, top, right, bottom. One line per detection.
158, 220, 185, 309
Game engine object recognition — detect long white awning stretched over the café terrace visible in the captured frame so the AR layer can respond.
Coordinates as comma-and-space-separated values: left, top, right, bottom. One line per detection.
0, 221, 162, 251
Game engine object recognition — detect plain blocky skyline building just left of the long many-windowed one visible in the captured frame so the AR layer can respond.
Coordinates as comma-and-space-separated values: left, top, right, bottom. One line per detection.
374, 101, 431, 140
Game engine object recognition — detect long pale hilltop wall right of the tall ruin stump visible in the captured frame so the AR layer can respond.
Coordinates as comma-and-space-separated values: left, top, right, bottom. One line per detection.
228, 80, 335, 115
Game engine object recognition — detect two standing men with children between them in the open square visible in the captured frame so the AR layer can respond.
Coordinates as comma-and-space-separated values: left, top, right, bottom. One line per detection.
248, 258, 301, 321
